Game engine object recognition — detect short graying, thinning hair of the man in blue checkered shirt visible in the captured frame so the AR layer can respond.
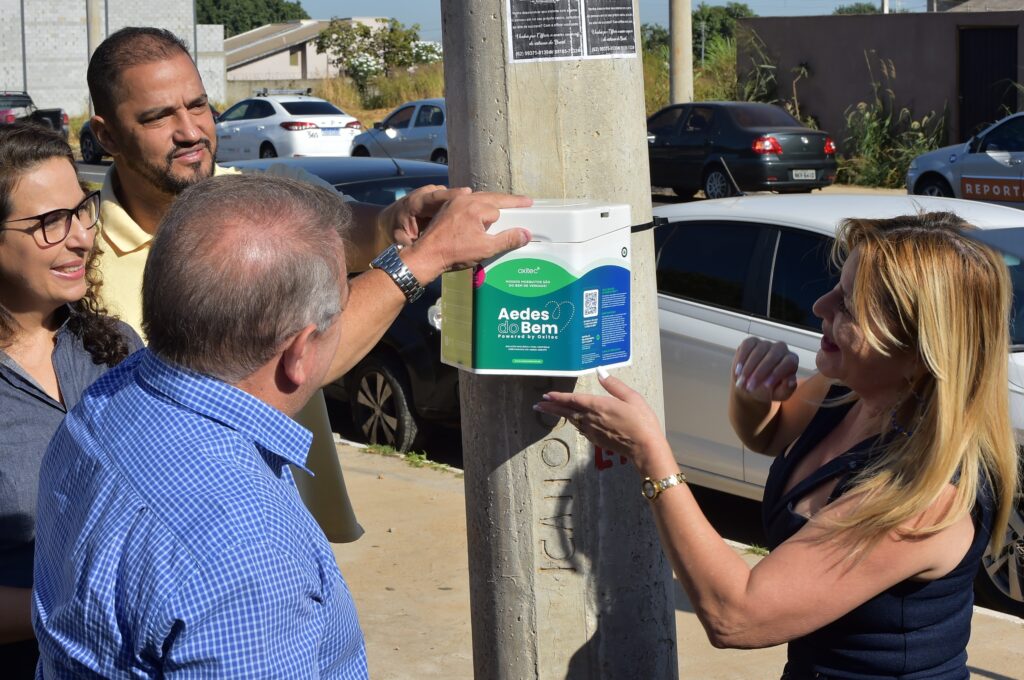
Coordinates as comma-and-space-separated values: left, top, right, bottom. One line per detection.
142, 175, 351, 383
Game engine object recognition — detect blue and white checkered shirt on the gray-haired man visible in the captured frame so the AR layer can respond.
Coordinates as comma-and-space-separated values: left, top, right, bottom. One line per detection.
33, 350, 368, 679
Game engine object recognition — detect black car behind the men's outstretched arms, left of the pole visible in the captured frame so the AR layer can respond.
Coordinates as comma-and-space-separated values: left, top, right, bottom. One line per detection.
224, 158, 459, 452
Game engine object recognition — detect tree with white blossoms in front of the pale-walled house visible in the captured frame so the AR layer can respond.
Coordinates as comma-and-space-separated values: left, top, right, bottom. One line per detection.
316, 18, 440, 92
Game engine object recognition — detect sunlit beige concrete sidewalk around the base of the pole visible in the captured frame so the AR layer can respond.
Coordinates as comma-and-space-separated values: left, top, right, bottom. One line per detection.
334, 445, 1024, 680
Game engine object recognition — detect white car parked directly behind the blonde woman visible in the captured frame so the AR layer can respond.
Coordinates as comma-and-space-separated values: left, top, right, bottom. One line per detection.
654, 195, 1024, 615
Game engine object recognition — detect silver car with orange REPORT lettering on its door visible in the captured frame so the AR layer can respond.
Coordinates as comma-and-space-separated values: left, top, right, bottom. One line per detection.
906, 114, 1024, 207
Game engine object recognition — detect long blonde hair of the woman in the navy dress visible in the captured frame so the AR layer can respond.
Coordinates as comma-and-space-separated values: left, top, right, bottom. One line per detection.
833, 213, 1020, 547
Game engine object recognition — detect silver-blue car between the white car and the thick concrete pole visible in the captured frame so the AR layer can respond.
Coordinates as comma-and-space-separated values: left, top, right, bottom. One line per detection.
352, 99, 447, 165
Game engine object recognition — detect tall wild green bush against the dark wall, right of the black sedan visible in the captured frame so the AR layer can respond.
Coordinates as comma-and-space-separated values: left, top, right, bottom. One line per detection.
838, 52, 946, 188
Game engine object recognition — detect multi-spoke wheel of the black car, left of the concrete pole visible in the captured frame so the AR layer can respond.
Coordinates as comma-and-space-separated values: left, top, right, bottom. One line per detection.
349, 354, 419, 452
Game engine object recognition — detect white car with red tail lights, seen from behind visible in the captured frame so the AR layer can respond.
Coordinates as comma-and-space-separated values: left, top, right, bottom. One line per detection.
217, 94, 362, 161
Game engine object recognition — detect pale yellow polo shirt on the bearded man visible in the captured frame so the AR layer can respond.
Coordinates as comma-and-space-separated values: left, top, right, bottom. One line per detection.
98, 165, 239, 338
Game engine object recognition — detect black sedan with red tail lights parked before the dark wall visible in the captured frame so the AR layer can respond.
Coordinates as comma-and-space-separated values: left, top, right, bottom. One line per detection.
647, 101, 836, 199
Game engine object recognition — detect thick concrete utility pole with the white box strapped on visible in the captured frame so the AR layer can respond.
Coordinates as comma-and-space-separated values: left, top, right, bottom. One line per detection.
441, 0, 678, 680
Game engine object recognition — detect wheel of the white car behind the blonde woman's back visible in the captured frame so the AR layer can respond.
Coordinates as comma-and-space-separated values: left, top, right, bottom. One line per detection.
974, 507, 1024, 617
